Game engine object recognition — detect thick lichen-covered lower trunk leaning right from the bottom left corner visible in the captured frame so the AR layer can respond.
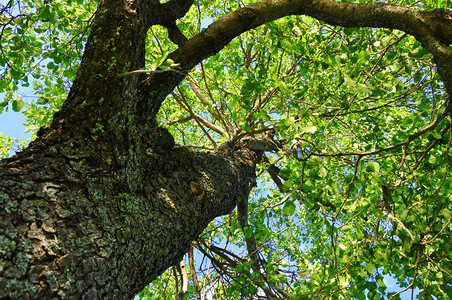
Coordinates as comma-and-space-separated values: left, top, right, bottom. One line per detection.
0, 137, 254, 299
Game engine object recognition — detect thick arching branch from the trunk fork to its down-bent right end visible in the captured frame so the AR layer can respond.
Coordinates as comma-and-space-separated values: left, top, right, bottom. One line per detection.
139, 0, 452, 126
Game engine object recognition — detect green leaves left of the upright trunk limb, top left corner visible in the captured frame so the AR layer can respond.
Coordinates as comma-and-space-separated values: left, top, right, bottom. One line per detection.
0, 0, 96, 155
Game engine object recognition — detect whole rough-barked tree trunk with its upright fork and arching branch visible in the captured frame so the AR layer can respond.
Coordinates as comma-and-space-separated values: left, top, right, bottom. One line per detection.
0, 0, 452, 299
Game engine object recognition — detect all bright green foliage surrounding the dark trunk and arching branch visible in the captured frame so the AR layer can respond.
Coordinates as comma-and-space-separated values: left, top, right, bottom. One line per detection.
0, 0, 452, 299
